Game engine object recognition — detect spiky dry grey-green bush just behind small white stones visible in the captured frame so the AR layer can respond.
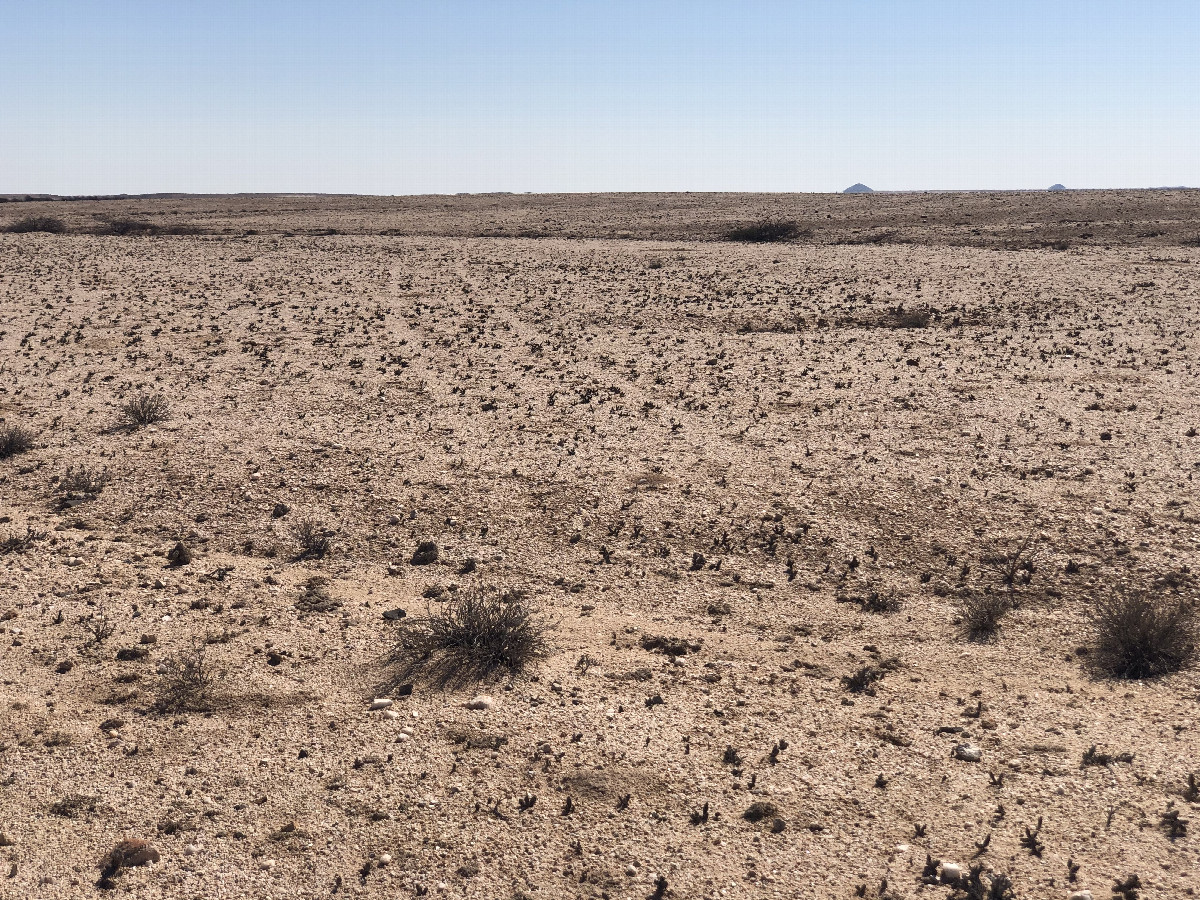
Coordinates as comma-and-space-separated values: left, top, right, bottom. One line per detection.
397, 587, 547, 680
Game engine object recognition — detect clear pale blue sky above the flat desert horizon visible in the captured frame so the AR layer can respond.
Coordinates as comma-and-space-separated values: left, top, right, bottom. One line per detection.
0, 0, 1200, 194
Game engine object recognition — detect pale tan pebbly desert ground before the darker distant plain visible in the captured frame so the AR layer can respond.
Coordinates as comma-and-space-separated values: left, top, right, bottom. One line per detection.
0, 196, 1200, 900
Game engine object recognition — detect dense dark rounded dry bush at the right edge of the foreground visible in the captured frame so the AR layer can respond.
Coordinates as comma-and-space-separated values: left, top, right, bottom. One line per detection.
1092, 590, 1200, 678
